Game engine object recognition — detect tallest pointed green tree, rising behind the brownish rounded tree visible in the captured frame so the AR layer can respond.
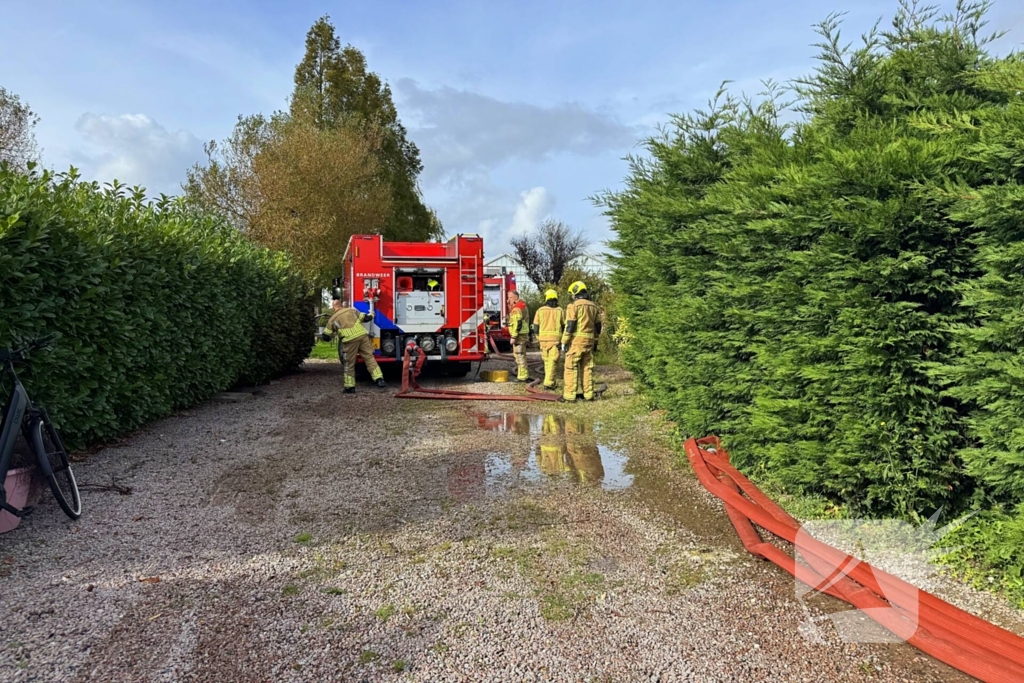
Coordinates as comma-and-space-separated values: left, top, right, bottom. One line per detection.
291, 15, 443, 240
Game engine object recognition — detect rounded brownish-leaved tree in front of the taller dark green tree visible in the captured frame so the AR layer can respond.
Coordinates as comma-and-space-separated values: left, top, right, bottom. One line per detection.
183, 114, 391, 285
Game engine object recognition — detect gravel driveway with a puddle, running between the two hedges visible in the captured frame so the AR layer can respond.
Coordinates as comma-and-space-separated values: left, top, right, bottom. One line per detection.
0, 361, 1015, 683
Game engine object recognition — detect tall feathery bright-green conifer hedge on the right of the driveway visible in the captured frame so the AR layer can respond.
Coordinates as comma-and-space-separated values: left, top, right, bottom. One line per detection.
598, 4, 1024, 528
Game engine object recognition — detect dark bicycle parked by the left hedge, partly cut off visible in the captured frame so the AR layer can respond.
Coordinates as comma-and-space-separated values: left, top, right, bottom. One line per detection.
0, 334, 82, 519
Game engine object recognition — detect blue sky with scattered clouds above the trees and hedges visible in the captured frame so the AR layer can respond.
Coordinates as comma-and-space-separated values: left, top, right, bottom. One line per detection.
0, 0, 1024, 256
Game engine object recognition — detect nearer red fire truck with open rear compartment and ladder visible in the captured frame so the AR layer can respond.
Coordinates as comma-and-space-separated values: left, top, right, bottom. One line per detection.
341, 234, 487, 376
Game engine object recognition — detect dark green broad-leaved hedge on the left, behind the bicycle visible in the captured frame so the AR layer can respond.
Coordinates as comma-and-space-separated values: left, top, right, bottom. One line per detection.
0, 168, 315, 446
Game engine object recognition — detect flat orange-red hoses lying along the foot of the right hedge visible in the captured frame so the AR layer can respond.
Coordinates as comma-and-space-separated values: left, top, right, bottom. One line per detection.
685, 436, 1024, 683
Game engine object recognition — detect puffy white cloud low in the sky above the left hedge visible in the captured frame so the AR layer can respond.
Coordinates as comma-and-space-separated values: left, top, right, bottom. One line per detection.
75, 113, 203, 196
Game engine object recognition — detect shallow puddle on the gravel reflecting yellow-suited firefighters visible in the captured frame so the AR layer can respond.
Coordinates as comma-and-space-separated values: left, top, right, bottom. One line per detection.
462, 413, 633, 496
